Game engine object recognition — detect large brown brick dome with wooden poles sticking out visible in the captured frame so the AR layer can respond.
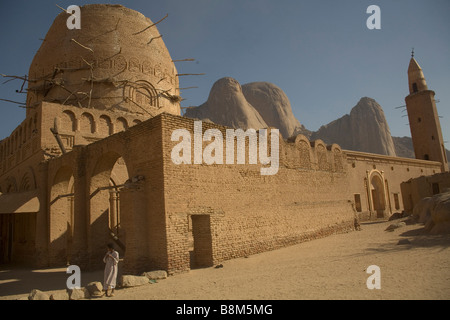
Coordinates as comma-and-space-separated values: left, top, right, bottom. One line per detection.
27, 4, 180, 116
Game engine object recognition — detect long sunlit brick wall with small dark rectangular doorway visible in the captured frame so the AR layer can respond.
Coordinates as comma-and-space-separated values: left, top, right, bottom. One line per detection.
162, 115, 354, 271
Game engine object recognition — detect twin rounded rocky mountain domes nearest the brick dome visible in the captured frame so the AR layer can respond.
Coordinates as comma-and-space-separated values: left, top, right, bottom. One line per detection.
185, 78, 300, 138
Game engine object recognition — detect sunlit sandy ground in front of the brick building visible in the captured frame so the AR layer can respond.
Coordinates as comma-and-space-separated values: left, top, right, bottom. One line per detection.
0, 222, 450, 300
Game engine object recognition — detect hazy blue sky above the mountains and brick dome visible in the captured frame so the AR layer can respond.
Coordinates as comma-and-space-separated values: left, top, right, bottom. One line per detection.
0, 0, 450, 145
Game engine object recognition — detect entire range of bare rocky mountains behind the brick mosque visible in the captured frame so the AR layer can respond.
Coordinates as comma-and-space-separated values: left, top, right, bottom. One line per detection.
184, 77, 450, 158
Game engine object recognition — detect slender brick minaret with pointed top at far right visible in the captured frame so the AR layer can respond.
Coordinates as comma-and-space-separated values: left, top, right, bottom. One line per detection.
405, 51, 448, 172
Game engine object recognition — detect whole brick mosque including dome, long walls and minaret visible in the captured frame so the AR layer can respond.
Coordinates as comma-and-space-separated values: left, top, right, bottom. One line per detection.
0, 4, 448, 274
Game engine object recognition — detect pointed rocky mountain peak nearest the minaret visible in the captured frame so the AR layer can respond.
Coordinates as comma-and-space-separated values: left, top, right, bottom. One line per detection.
310, 97, 396, 156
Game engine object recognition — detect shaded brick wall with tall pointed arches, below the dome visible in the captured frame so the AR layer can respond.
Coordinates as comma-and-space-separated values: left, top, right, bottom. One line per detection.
48, 118, 167, 273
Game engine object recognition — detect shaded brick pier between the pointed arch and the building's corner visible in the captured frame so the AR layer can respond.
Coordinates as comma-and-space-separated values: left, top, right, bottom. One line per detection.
120, 117, 168, 273
